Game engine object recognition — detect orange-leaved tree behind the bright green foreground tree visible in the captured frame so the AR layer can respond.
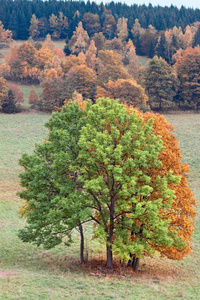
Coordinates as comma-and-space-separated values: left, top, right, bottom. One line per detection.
91, 105, 197, 269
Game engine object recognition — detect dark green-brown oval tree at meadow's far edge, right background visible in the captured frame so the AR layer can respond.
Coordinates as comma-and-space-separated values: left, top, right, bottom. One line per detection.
144, 56, 178, 109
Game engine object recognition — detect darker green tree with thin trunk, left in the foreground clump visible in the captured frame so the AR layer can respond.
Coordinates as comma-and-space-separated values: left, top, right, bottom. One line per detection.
19, 103, 90, 262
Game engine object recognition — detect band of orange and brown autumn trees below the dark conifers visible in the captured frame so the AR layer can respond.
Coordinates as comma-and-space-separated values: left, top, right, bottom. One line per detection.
0, 26, 200, 113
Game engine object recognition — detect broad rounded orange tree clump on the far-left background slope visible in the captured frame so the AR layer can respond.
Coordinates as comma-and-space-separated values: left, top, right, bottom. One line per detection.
4, 35, 65, 83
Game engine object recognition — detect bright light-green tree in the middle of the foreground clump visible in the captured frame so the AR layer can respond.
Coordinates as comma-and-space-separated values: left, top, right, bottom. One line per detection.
70, 98, 191, 267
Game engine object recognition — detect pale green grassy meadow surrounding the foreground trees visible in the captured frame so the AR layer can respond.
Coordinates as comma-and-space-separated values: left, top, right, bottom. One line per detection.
0, 113, 200, 300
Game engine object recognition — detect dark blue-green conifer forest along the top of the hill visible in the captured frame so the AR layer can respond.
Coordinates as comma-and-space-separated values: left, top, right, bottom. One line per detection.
0, 0, 200, 40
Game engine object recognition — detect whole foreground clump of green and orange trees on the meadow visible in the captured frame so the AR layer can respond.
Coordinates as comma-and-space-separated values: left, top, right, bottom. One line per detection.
19, 98, 196, 269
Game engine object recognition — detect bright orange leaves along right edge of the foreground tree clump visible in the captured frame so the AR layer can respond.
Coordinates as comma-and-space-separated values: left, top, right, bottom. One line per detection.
139, 113, 197, 259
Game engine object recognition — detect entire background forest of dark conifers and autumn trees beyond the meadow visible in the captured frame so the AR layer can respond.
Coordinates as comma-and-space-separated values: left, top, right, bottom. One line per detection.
0, 0, 200, 113
